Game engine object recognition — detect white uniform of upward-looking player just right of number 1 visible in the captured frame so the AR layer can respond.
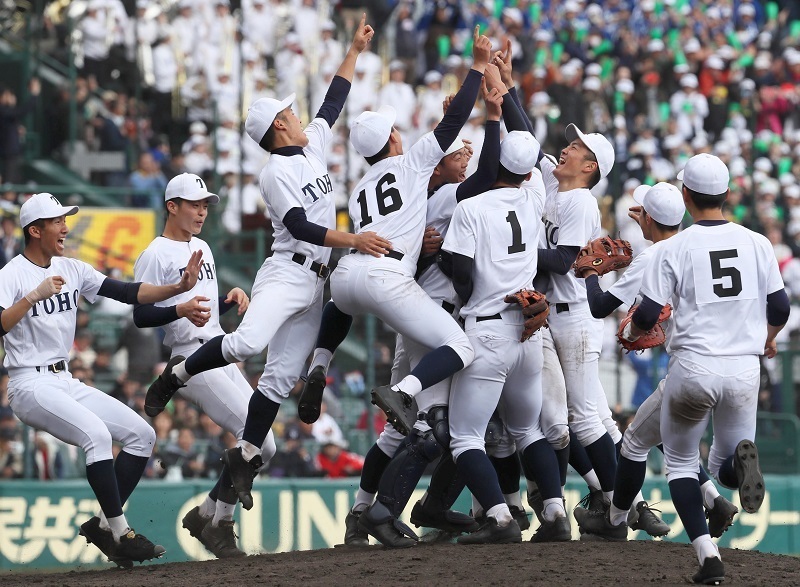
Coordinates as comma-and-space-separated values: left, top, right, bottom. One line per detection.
540, 157, 621, 448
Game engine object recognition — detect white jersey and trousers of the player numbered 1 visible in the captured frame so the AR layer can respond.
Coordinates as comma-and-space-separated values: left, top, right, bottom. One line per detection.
443, 170, 544, 460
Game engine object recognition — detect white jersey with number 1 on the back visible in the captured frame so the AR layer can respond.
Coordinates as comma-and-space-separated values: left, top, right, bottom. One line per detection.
453, 178, 544, 316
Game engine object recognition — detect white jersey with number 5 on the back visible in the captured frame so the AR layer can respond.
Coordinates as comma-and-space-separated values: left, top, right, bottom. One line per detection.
642, 223, 783, 355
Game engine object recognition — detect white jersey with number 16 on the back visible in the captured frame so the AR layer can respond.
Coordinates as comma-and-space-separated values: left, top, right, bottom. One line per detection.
349, 133, 444, 265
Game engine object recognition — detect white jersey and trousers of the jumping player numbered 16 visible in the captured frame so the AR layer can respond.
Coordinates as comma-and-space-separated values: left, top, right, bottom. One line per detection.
331, 133, 473, 372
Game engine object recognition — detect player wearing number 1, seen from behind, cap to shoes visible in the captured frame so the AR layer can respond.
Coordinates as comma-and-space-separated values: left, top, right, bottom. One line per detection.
443, 131, 570, 544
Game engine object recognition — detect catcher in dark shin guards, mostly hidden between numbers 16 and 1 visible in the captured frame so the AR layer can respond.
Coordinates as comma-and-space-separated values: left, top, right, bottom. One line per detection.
342, 76, 502, 548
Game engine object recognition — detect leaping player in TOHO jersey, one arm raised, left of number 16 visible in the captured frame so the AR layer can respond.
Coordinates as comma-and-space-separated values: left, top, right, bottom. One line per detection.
145, 16, 391, 510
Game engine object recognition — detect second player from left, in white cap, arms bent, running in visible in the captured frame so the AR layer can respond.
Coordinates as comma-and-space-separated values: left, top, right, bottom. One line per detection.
133, 173, 275, 558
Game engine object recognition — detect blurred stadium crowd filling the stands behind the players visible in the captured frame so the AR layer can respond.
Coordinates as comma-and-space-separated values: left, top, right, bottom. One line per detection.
0, 0, 800, 479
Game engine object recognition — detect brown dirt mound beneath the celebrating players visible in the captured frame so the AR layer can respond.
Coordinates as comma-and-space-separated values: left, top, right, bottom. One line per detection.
0, 541, 800, 587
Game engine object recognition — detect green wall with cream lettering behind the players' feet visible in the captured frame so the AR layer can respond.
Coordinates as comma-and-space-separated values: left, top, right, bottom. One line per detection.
0, 476, 800, 570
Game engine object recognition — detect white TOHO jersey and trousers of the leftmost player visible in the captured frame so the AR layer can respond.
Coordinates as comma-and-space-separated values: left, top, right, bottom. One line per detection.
0, 255, 156, 465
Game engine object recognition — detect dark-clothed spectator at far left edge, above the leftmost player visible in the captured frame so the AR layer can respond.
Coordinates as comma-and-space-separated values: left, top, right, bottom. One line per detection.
0, 78, 42, 184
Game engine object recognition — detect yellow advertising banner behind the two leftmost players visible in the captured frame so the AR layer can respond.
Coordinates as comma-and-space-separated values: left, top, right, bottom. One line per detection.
66, 206, 156, 279
